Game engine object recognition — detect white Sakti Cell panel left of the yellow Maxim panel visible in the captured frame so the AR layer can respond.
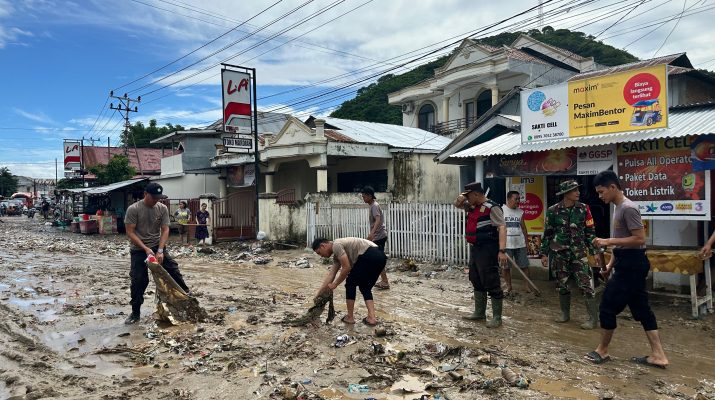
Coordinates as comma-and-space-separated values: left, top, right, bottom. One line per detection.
520, 83, 569, 143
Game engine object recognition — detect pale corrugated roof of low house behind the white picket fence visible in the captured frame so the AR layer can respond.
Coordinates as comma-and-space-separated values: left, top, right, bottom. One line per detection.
321, 117, 451, 151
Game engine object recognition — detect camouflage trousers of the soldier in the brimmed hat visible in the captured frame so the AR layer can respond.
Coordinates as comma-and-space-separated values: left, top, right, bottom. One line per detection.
550, 251, 595, 298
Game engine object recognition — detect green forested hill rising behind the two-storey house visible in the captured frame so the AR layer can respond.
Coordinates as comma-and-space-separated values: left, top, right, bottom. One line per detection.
330, 26, 638, 125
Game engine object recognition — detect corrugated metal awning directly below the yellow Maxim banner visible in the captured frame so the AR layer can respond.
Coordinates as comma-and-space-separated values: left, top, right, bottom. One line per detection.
451, 106, 715, 158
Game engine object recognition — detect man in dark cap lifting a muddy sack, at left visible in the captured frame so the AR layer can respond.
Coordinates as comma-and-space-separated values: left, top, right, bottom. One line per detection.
124, 182, 190, 325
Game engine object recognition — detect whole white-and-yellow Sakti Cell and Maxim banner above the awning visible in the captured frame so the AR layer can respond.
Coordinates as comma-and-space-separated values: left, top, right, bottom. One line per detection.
520, 64, 668, 143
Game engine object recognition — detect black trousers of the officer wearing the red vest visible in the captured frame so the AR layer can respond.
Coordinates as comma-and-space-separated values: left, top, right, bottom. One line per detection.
469, 241, 504, 299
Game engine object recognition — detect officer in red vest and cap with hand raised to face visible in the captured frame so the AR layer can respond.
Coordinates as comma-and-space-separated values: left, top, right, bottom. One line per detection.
454, 182, 507, 328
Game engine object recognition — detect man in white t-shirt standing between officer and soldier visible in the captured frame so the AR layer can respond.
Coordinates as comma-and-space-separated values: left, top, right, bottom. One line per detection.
502, 190, 529, 293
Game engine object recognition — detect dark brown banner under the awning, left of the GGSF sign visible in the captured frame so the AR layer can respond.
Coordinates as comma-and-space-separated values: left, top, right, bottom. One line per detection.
486, 148, 576, 176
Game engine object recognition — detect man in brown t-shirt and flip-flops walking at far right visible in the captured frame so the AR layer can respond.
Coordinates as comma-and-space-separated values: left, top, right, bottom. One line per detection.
585, 171, 668, 368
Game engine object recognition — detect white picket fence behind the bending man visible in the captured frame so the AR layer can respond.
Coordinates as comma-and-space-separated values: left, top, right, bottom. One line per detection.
306, 202, 469, 264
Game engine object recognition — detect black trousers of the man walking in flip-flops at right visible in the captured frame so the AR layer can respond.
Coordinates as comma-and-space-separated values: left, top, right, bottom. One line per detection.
599, 249, 658, 331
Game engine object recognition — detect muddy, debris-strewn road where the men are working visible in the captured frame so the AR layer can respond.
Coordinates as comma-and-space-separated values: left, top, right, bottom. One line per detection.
0, 217, 715, 400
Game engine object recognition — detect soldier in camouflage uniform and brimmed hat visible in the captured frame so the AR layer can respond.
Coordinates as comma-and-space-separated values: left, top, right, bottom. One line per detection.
541, 180, 598, 329
